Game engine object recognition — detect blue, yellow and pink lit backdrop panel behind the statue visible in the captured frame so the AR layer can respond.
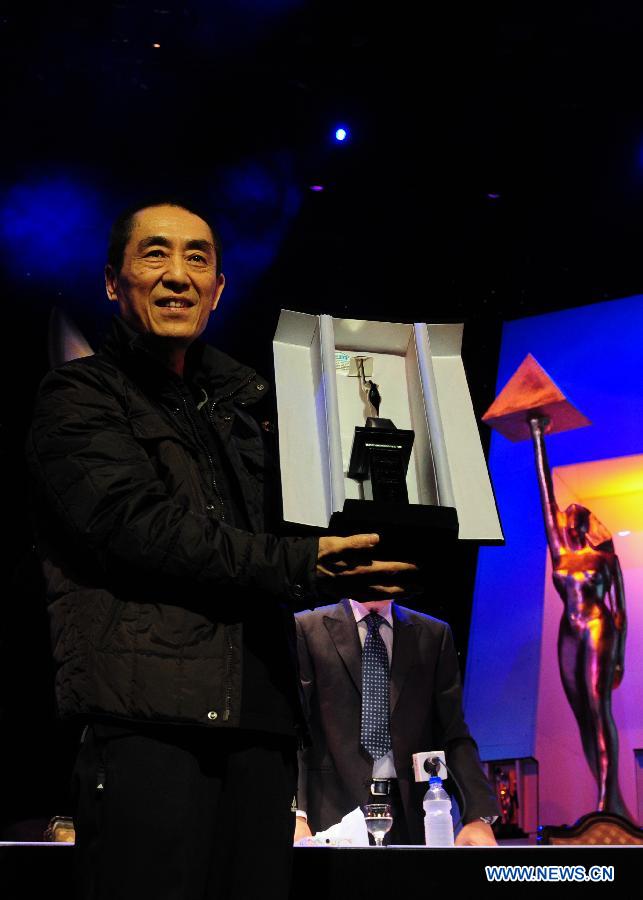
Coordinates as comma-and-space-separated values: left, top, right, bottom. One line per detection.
465, 296, 643, 824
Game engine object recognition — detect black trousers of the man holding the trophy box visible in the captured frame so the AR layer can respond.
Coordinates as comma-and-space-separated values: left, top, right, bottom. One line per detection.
73, 725, 297, 900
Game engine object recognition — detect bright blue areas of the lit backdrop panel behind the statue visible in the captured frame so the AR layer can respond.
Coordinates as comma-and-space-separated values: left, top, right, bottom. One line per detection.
465, 296, 643, 759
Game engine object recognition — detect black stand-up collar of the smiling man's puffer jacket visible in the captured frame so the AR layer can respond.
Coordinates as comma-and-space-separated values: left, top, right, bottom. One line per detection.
100, 316, 269, 406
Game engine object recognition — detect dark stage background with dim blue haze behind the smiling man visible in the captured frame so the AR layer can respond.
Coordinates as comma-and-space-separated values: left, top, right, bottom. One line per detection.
0, 0, 643, 838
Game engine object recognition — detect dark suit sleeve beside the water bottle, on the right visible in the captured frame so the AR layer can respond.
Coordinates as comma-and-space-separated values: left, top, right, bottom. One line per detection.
435, 624, 499, 823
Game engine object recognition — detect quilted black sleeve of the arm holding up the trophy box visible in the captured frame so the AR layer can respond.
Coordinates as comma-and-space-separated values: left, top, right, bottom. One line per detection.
27, 363, 317, 602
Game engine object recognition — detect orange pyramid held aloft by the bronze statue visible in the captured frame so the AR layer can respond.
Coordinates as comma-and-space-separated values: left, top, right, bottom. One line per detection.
482, 353, 592, 441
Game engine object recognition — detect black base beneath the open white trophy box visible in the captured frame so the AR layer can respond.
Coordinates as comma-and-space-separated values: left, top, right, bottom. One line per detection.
328, 500, 458, 562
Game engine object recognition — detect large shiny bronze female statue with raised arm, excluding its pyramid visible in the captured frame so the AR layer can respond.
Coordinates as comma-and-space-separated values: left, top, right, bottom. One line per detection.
529, 417, 631, 819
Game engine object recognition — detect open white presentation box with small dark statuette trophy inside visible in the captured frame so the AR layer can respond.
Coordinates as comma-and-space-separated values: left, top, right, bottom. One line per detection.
273, 310, 502, 559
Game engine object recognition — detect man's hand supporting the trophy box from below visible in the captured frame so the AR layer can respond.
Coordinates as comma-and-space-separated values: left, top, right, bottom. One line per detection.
317, 534, 418, 600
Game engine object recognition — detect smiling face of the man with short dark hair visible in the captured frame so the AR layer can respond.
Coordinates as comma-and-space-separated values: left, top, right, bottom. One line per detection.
105, 206, 225, 347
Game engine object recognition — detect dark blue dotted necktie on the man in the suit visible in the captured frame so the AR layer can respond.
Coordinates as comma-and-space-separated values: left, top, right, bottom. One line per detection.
360, 612, 391, 759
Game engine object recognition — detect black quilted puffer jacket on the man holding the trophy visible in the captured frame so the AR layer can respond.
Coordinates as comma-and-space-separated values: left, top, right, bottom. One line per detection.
27, 318, 317, 730
